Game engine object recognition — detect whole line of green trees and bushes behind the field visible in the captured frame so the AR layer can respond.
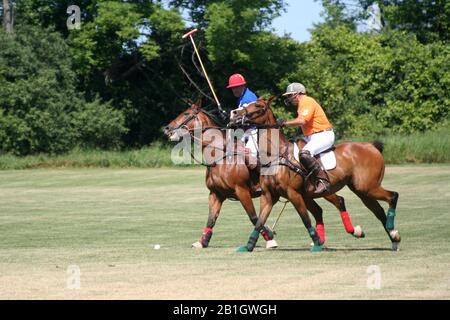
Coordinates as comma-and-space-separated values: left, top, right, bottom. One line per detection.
0, 0, 450, 155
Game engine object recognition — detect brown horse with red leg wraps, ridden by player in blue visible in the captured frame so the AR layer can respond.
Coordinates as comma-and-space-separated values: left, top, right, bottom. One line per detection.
164, 101, 364, 248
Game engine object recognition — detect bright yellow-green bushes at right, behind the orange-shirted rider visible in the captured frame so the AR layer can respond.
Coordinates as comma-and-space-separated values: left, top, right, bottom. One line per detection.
280, 24, 450, 136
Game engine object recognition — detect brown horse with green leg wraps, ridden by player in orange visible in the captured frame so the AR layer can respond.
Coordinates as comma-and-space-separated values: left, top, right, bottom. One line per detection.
231, 99, 400, 251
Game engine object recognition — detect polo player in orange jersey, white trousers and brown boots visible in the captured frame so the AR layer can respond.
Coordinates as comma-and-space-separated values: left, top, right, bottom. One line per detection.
279, 82, 334, 194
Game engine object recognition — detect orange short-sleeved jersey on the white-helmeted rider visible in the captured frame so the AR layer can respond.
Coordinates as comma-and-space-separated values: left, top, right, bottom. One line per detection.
297, 95, 333, 136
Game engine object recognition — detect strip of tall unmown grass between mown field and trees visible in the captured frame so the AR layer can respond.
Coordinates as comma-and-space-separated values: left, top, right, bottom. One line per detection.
0, 124, 450, 170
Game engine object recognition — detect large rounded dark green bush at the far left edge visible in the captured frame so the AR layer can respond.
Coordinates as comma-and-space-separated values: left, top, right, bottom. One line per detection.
0, 26, 125, 155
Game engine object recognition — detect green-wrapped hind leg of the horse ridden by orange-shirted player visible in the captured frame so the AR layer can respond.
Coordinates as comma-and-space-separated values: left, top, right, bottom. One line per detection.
355, 186, 401, 251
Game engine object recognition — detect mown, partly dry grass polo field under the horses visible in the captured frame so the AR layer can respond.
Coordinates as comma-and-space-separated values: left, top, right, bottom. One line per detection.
0, 165, 450, 299
